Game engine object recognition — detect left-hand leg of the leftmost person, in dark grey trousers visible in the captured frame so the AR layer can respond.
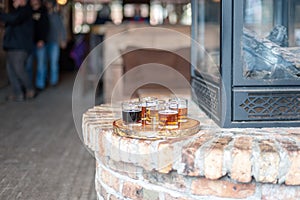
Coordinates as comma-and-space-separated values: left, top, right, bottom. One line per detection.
6, 51, 24, 101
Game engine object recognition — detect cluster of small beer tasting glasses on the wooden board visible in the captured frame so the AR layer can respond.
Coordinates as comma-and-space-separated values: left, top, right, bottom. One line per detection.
122, 97, 188, 129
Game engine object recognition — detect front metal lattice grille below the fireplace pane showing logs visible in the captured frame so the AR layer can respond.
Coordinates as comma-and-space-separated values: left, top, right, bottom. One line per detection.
240, 93, 300, 120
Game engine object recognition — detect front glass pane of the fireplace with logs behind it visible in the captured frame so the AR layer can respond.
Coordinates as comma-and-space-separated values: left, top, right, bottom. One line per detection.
242, 0, 300, 80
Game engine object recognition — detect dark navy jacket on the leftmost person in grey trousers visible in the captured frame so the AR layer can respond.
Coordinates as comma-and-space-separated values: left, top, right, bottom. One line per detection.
0, 4, 33, 51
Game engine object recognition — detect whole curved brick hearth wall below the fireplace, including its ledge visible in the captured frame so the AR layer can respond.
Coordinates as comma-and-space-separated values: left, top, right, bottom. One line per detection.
82, 106, 300, 200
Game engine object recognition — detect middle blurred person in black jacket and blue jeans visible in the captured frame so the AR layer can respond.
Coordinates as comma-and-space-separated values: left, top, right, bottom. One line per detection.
27, 0, 49, 91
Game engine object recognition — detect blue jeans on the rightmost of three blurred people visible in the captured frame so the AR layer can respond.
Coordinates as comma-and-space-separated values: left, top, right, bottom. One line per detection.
47, 42, 60, 85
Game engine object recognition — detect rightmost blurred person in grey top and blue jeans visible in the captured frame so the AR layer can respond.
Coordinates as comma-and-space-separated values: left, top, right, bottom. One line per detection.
45, 0, 67, 86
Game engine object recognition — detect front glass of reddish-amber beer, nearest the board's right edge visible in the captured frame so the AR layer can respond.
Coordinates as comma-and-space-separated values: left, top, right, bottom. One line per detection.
158, 110, 178, 129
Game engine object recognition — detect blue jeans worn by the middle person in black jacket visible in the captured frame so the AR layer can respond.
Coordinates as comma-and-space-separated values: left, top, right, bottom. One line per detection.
26, 46, 47, 89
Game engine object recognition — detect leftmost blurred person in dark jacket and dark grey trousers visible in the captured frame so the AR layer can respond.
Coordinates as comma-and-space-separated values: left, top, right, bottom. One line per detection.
0, 0, 35, 101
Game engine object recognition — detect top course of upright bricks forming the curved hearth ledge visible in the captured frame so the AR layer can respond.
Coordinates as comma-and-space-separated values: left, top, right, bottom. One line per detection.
82, 106, 300, 185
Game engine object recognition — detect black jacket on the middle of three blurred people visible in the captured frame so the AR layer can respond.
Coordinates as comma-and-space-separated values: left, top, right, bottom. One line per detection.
32, 6, 49, 43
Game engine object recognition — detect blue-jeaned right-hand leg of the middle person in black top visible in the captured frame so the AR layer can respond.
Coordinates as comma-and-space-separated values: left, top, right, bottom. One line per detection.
35, 47, 47, 90
